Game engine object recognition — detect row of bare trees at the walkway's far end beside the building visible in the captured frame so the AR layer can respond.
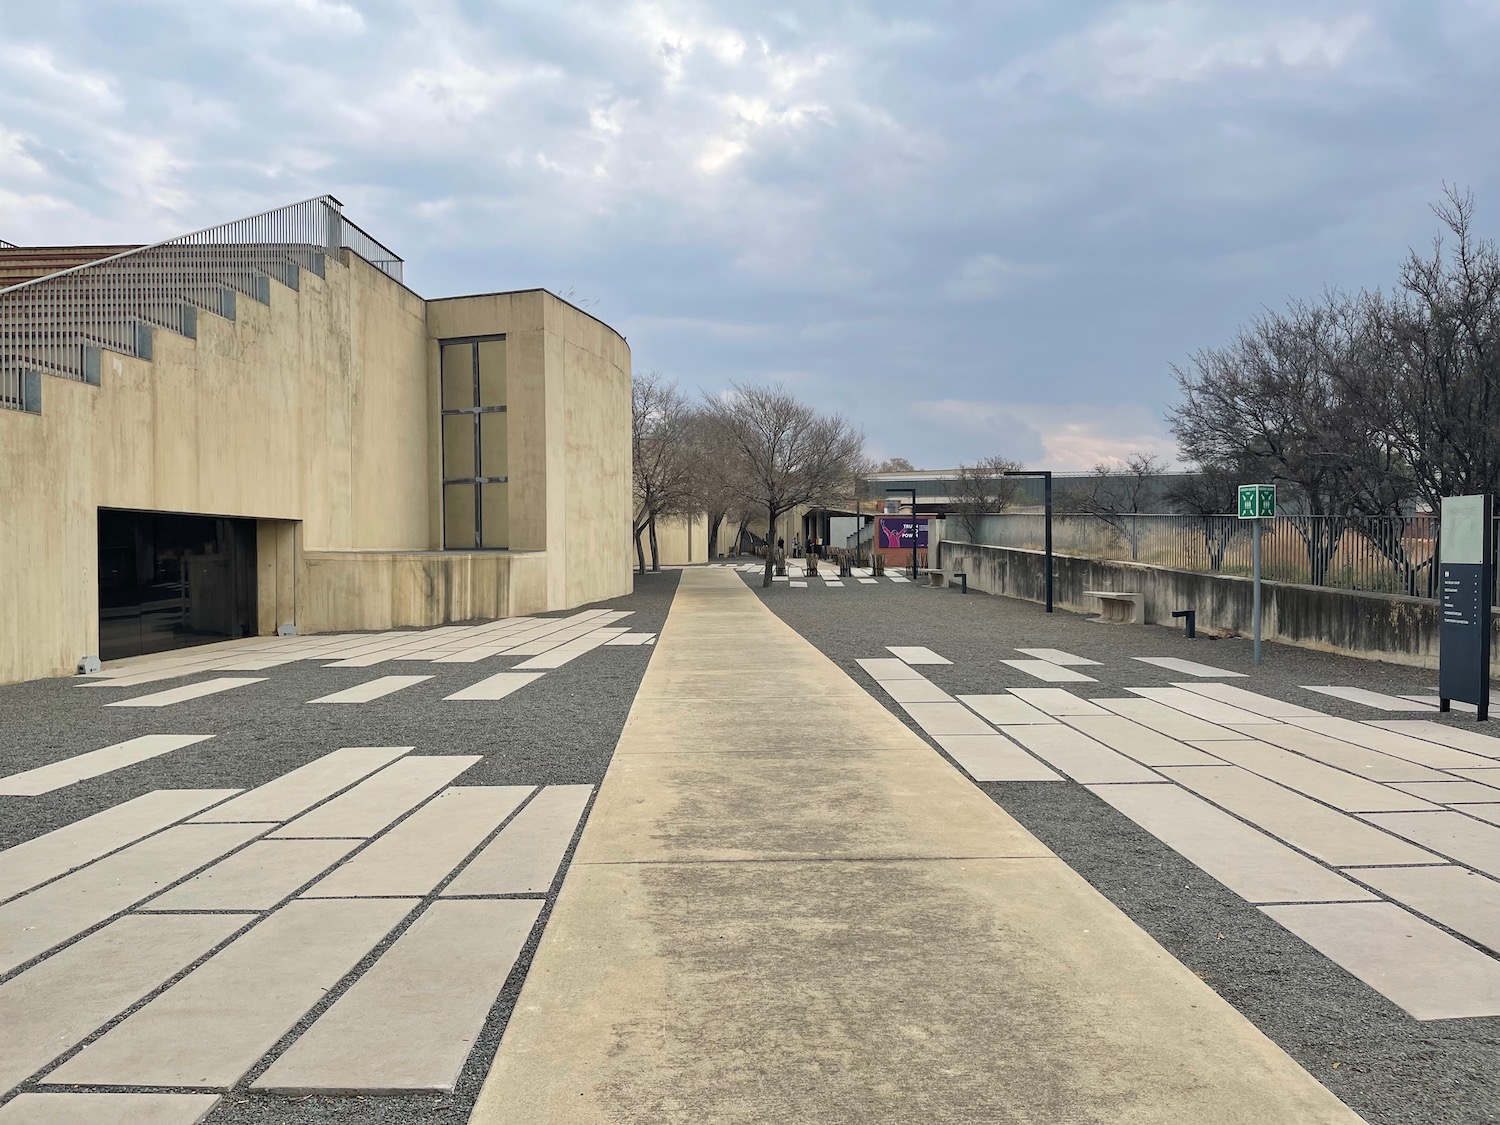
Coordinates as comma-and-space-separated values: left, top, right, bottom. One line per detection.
632, 379, 867, 587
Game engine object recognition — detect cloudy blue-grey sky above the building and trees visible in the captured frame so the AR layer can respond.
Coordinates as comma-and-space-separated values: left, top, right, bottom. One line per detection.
0, 0, 1500, 468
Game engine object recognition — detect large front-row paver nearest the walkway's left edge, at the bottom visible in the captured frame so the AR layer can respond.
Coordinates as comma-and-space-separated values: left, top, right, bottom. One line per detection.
255, 899, 542, 1092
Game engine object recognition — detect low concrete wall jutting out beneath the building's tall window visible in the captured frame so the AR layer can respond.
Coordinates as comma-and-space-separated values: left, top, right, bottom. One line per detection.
297, 551, 548, 633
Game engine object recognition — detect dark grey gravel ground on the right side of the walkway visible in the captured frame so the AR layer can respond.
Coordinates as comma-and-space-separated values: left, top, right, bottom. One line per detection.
746, 575, 1500, 1125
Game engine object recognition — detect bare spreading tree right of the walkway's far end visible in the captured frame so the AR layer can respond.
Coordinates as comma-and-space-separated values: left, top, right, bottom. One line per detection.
704, 383, 864, 587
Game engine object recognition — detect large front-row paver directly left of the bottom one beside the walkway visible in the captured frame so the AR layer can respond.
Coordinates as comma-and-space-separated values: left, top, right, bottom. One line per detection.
47, 899, 417, 1089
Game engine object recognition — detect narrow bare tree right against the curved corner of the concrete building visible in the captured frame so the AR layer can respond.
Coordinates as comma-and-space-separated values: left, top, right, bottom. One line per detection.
630, 371, 698, 575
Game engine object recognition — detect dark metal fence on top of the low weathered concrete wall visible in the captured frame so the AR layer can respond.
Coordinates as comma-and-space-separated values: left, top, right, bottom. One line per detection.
944, 513, 1500, 603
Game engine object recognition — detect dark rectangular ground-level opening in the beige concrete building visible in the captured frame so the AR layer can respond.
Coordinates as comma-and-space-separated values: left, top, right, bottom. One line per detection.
99, 509, 255, 660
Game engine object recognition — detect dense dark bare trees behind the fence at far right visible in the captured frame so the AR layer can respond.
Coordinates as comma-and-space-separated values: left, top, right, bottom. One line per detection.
1170, 189, 1500, 585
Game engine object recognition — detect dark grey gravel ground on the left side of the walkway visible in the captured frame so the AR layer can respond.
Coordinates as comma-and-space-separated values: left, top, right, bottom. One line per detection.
0, 572, 678, 1125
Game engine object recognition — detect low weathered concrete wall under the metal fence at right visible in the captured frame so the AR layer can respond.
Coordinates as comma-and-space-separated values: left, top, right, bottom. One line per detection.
942, 540, 1500, 671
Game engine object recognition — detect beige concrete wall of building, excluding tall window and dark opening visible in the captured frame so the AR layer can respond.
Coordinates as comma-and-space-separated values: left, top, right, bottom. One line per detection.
0, 268, 632, 683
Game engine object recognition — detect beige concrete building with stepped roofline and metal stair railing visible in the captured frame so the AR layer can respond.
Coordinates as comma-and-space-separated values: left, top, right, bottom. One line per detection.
0, 197, 633, 681
